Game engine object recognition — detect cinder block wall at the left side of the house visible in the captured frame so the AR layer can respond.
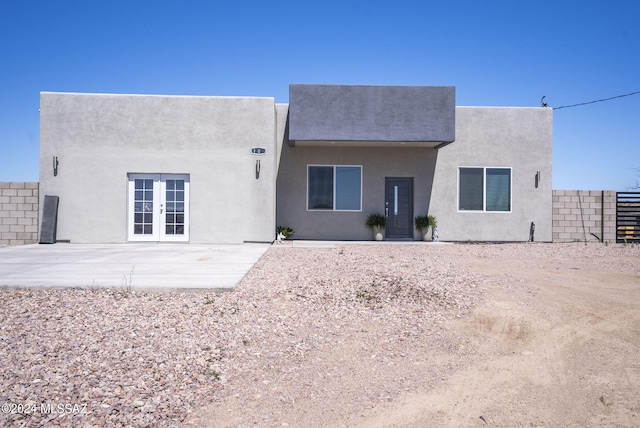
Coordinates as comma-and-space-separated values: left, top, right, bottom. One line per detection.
0, 182, 38, 245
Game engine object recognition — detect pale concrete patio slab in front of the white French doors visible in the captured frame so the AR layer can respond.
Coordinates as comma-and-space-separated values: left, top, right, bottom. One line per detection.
0, 243, 270, 291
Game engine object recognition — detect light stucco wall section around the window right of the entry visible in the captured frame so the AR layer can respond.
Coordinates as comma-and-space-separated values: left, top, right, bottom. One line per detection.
429, 107, 553, 241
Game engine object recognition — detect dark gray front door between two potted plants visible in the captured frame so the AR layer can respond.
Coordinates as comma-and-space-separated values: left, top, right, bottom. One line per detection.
385, 177, 413, 239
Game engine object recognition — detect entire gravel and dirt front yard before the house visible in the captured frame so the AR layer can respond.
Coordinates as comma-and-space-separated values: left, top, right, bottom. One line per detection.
0, 243, 640, 427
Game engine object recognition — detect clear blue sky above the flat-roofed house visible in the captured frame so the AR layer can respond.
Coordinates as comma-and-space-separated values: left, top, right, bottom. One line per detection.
0, 0, 640, 190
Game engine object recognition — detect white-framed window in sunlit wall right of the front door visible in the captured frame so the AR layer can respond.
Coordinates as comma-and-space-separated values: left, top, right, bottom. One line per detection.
458, 168, 511, 212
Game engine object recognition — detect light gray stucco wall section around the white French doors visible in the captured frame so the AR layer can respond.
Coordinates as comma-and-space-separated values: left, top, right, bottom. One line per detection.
40, 93, 277, 243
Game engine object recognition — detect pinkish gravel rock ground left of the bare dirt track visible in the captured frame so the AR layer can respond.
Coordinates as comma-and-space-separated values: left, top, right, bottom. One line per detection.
0, 244, 638, 427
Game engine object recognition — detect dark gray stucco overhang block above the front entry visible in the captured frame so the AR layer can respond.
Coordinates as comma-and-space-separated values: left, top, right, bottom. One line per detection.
289, 85, 455, 147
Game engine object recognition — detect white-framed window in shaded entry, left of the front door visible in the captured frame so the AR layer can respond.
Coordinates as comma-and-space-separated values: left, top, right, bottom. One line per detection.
307, 165, 362, 211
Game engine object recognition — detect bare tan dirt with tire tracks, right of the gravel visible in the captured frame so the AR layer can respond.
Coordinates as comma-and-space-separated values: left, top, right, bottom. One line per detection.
350, 256, 640, 427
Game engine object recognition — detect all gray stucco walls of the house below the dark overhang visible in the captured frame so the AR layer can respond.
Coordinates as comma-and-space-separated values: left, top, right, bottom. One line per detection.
40, 93, 552, 243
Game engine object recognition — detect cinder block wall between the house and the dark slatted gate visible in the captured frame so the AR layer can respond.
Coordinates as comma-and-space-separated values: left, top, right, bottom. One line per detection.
553, 190, 616, 242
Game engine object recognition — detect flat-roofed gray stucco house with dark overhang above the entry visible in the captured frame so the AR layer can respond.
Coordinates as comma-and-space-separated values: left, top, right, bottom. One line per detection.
40, 85, 552, 243
